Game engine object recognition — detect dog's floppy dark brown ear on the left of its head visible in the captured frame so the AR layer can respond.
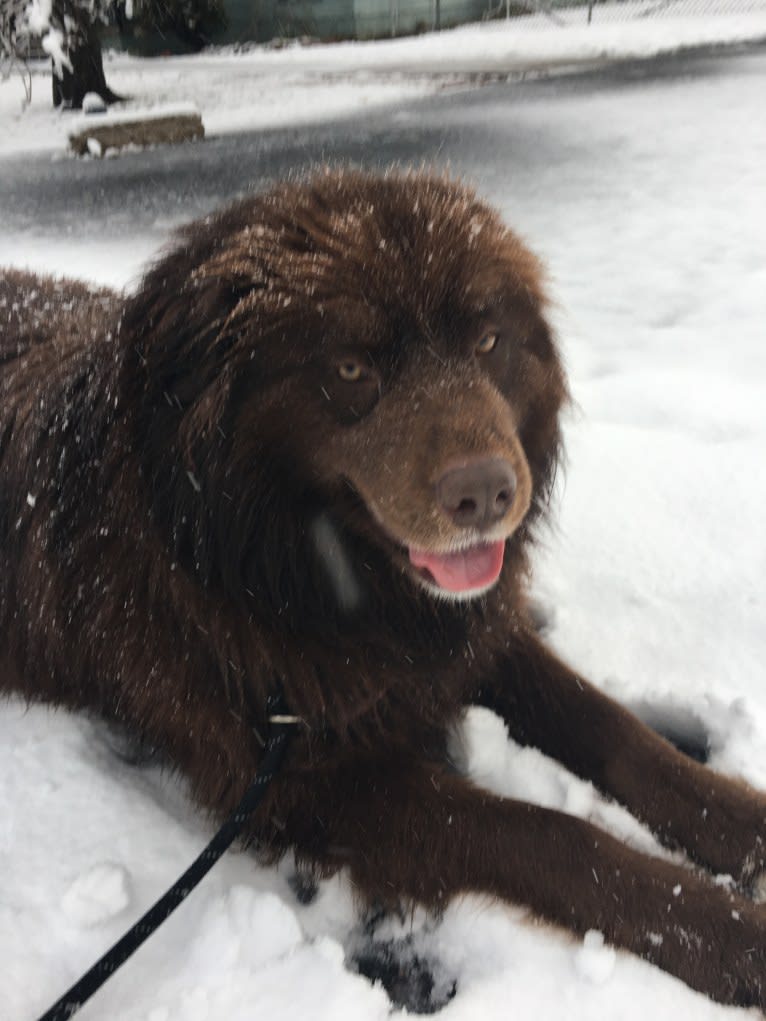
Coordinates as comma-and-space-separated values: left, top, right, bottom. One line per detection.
118, 239, 258, 579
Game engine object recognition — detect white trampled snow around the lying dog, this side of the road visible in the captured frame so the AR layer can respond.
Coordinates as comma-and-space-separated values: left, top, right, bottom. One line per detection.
0, 17, 766, 1021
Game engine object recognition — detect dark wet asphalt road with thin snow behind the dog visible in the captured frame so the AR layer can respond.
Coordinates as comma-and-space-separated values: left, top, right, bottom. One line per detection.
0, 45, 766, 238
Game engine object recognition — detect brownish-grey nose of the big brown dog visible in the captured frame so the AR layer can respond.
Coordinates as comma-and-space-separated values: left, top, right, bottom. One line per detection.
436, 457, 516, 528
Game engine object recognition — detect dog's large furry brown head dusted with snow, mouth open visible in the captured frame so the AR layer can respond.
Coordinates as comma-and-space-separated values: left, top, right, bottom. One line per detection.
124, 172, 566, 612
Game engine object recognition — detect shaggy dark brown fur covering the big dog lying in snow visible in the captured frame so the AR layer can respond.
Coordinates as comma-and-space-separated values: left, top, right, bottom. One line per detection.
0, 173, 766, 1006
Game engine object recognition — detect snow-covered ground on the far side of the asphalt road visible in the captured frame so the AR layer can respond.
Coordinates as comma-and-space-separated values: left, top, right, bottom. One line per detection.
0, 0, 766, 155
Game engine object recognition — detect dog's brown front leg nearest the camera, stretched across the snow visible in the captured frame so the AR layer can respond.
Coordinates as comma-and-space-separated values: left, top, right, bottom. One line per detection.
298, 761, 766, 1006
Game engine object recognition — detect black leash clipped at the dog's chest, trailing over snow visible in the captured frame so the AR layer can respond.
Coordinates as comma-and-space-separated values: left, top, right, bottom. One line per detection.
38, 695, 298, 1021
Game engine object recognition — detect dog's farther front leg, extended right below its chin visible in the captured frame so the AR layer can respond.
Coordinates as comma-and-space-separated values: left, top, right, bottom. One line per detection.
475, 632, 766, 884
